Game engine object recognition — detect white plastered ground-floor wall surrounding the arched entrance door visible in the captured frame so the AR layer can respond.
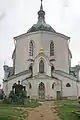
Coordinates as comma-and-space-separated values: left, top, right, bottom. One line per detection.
24, 78, 61, 99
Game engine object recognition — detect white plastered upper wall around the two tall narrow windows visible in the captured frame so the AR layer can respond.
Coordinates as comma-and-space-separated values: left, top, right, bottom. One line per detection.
15, 32, 69, 73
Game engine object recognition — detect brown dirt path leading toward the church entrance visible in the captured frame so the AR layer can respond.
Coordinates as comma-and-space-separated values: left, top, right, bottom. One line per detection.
28, 101, 59, 120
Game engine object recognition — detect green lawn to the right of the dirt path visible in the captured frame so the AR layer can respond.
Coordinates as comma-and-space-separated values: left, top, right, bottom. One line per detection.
57, 100, 80, 120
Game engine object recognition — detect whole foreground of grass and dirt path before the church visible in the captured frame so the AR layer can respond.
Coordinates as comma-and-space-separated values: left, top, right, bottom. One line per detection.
0, 100, 80, 120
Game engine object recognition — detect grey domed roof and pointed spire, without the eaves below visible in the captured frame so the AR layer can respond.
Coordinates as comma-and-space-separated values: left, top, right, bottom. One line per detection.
27, 0, 56, 33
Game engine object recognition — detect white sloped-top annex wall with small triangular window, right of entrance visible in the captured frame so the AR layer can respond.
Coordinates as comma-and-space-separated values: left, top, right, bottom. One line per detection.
53, 73, 80, 98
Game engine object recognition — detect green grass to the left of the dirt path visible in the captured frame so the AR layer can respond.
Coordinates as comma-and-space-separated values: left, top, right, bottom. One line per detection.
0, 100, 40, 120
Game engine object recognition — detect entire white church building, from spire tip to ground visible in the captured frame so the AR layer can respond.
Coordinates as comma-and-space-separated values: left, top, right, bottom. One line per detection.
3, 2, 80, 99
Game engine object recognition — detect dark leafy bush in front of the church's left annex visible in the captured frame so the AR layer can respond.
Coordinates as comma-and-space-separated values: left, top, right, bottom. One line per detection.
4, 81, 27, 104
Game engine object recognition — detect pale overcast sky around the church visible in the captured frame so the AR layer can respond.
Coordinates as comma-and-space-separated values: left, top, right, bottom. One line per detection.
0, 0, 80, 83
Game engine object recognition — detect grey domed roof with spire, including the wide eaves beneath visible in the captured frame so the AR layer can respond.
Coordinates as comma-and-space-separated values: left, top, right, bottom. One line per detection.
14, 2, 70, 40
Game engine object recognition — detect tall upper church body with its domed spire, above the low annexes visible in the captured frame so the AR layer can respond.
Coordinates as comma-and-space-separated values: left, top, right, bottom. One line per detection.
13, 0, 71, 76
